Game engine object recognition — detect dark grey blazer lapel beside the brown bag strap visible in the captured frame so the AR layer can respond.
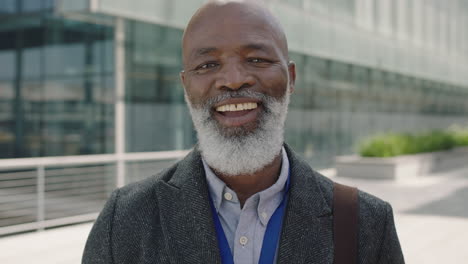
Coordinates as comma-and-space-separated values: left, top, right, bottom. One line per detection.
278, 145, 333, 263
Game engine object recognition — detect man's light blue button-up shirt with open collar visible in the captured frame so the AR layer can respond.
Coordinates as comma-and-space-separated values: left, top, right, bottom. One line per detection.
203, 147, 289, 264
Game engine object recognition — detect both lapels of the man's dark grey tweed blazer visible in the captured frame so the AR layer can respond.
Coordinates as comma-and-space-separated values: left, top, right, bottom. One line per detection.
157, 144, 333, 263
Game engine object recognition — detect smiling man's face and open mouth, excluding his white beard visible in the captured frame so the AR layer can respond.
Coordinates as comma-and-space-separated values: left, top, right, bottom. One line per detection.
181, 6, 295, 134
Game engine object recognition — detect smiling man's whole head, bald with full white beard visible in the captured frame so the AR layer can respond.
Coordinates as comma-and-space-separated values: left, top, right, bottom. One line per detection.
181, 4, 295, 175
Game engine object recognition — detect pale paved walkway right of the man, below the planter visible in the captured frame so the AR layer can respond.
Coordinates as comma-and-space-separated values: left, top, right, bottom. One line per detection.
332, 167, 468, 264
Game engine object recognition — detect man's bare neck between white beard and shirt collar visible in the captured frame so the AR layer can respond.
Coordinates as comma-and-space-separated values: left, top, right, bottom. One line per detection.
215, 152, 282, 207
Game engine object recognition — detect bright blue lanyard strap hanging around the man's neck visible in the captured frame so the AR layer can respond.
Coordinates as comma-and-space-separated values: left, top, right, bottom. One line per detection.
210, 169, 290, 264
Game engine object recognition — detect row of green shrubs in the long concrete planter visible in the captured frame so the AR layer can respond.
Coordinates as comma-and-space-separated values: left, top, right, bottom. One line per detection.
359, 129, 468, 157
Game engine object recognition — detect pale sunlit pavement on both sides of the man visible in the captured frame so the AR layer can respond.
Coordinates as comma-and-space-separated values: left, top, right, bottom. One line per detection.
0, 168, 468, 264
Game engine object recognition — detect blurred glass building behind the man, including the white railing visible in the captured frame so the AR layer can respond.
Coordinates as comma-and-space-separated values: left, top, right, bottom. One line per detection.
0, 0, 468, 235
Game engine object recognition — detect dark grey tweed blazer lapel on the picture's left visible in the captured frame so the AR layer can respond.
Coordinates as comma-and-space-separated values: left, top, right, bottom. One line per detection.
157, 150, 221, 263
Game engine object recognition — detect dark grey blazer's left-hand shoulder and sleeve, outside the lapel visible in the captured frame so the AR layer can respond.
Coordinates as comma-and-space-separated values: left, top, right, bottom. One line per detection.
83, 164, 181, 263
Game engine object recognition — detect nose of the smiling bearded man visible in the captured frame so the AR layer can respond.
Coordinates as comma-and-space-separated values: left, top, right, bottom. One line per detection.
216, 62, 255, 90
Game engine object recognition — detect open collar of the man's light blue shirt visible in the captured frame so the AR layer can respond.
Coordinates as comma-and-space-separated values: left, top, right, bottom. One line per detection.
202, 147, 289, 225
